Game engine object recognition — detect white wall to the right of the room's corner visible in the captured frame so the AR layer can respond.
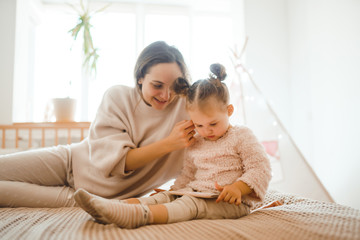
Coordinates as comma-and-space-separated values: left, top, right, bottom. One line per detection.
289, 0, 360, 209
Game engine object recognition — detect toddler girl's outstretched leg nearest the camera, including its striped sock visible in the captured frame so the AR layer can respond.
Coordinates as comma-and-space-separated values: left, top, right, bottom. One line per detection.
90, 196, 250, 228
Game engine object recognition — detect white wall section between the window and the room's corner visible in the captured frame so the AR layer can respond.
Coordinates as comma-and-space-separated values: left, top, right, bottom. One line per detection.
245, 0, 291, 129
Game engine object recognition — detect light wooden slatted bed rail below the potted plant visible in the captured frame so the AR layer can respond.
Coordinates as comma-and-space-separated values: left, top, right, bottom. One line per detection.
0, 122, 90, 149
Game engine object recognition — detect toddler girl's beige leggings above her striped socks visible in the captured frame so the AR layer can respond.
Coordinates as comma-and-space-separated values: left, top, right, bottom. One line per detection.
138, 191, 250, 223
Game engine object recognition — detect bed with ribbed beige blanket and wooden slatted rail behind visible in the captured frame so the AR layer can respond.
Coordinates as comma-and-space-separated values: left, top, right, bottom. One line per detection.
0, 123, 360, 240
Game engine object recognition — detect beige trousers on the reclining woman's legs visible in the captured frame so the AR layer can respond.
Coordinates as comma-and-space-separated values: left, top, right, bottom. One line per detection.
0, 146, 75, 208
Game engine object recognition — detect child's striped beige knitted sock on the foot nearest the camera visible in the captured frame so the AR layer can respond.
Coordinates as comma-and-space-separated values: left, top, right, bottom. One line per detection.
90, 198, 153, 228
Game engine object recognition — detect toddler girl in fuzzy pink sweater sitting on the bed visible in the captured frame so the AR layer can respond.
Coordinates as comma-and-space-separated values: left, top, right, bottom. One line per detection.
75, 64, 271, 228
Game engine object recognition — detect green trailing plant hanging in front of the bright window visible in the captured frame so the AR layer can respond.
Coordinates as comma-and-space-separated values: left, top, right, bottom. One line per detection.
69, 0, 108, 75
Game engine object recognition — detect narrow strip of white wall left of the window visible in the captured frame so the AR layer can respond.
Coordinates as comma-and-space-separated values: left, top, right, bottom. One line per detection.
0, 0, 16, 124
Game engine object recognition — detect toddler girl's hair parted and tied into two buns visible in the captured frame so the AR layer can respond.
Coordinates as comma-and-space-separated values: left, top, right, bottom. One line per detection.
173, 63, 229, 109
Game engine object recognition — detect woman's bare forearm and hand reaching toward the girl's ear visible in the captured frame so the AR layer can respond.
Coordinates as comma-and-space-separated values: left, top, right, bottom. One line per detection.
125, 120, 195, 171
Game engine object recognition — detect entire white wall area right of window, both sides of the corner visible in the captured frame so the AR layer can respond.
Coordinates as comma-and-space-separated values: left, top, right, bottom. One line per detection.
245, 0, 360, 209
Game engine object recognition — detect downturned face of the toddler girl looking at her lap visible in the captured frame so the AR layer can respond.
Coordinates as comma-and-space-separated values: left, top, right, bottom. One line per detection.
188, 99, 233, 141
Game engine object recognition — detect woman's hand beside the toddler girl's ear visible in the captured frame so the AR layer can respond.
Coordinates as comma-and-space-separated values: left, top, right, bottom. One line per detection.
165, 120, 195, 151
